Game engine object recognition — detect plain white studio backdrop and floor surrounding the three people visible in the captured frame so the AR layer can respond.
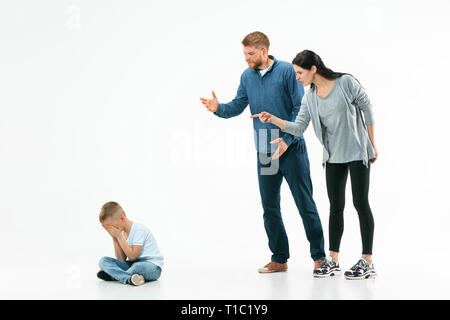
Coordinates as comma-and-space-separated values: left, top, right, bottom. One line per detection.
0, 0, 450, 299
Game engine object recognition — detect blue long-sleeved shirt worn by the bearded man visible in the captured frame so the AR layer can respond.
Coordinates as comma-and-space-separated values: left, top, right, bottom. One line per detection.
214, 55, 305, 153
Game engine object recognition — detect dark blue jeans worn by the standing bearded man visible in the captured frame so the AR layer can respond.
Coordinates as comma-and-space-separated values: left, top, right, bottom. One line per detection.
257, 138, 325, 263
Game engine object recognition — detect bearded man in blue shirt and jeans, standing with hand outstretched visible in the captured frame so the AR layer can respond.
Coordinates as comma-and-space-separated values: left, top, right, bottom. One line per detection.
200, 32, 325, 273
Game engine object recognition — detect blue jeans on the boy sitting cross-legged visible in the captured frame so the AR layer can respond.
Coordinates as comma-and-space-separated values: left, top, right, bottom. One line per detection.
98, 257, 161, 284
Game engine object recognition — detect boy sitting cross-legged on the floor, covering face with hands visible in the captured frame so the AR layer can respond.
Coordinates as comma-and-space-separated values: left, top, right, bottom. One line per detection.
97, 201, 164, 286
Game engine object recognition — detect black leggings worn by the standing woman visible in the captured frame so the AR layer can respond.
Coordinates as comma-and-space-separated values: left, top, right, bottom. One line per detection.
326, 161, 374, 254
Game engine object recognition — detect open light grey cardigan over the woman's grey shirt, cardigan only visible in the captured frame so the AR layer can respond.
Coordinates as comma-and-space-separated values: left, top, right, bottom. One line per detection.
282, 75, 375, 167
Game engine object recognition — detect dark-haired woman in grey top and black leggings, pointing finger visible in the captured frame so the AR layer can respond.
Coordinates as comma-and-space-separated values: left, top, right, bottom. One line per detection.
251, 50, 378, 279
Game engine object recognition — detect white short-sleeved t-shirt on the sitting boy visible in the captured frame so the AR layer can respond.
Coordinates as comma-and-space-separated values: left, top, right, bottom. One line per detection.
127, 222, 164, 268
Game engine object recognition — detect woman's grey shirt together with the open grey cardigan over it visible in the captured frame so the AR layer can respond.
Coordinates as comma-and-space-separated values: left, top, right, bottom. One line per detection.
283, 75, 375, 167
